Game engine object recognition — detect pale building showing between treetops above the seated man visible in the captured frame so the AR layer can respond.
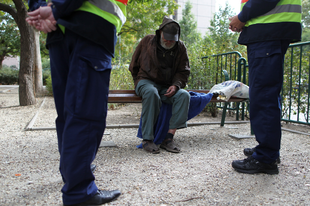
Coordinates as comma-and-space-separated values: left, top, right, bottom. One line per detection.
174, 0, 216, 36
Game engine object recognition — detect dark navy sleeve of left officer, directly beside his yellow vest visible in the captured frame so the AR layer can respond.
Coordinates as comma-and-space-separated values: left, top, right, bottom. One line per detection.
52, 0, 86, 20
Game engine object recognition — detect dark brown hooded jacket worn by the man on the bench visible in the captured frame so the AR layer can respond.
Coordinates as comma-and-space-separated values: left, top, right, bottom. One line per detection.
129, 17, 190, 89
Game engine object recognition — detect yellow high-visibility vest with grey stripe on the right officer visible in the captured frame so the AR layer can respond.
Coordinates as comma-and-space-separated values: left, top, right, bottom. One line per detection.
241, 0, 301, 27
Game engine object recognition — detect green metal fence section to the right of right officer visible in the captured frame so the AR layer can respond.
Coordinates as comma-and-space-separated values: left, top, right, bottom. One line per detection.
281, 42, 310, 125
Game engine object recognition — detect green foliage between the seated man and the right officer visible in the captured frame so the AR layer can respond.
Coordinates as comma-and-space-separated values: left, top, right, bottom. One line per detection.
187, 4, 246, 89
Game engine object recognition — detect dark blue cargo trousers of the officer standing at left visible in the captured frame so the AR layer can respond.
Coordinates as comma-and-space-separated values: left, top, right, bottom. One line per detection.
49, 30, 112, 205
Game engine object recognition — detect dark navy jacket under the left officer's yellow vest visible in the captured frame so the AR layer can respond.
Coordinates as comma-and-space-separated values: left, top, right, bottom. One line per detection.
28, 0, 117, 56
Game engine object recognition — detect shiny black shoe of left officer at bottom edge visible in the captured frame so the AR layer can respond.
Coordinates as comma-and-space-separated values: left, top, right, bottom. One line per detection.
64, 190, 121, 206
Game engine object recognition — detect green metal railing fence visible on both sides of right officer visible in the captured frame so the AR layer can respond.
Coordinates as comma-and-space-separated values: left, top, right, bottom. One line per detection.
189, 42, 310, 125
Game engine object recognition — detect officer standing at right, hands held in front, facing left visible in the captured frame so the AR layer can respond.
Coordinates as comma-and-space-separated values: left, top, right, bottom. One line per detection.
229, 0, 301, 174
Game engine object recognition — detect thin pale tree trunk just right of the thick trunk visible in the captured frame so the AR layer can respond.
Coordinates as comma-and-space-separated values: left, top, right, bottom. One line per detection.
34, 29, 43, 95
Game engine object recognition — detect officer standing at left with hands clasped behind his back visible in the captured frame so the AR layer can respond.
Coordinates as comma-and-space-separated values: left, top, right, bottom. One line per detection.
26, 0, 127, 205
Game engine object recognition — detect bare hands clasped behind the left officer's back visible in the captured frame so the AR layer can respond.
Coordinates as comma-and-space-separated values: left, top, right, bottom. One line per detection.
26, 5, 57, 33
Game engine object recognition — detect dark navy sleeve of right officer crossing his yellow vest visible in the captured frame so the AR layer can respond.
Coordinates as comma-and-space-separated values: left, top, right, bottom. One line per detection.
238, 0, 280, 22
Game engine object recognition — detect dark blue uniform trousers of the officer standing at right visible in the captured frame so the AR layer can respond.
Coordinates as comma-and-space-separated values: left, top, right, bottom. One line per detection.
247, 40, 290, 163
